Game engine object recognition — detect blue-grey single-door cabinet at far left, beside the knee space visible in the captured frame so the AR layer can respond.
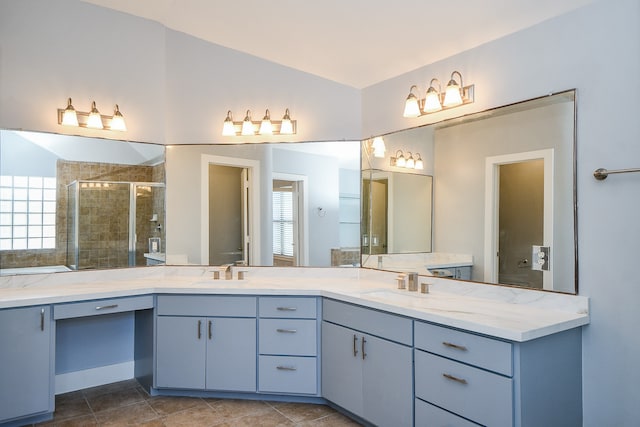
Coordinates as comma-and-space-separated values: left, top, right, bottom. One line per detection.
0, 306, 53, 425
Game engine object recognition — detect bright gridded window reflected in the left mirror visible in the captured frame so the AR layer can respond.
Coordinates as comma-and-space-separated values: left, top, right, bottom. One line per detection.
0, 176, 56, 250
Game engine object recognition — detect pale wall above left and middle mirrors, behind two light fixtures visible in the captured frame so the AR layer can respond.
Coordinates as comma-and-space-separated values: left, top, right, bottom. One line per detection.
0, 0, 361, 144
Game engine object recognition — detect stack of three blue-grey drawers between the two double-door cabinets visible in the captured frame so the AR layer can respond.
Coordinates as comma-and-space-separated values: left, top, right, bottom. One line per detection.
258, 296, 319, 395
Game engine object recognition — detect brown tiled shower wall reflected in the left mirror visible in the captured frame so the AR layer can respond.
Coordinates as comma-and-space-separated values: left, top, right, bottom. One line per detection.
0, 160, 164, 268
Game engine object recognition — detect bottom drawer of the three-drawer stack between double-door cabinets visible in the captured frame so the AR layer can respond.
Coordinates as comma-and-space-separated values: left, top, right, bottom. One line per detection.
258, 356, 318, 394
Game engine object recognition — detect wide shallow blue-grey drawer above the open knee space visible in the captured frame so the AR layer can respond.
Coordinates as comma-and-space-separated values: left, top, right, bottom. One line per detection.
53, 295, 153, 320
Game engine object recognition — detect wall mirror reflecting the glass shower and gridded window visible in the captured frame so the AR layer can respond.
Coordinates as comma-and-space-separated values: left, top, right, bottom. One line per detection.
0, 130, 165, 275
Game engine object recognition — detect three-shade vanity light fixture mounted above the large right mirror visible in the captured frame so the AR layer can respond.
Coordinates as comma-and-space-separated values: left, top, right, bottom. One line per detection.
403, 71, 474, 117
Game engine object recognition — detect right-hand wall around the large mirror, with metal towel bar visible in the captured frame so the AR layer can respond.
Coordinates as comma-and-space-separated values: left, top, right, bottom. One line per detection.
363, 0, 640, 427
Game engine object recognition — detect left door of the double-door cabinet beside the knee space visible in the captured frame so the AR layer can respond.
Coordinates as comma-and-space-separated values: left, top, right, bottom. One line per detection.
156, 316, 207, 389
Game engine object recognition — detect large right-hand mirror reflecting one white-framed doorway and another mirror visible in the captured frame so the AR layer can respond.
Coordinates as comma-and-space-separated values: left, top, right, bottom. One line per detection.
361, 90, 577, 293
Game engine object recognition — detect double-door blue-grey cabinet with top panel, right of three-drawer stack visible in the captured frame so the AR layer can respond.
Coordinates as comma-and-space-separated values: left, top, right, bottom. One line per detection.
322, 298, 413, 427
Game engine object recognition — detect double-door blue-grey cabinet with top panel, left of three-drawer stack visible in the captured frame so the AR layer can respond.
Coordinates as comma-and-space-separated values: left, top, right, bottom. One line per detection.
155, 295, 256, 392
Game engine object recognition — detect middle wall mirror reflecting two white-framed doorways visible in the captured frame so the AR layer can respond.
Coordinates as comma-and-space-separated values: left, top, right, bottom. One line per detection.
166, 141, 360, 267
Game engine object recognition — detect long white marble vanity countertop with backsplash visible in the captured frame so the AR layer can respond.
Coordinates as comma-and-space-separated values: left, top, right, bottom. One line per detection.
0, 266, 589, 341
